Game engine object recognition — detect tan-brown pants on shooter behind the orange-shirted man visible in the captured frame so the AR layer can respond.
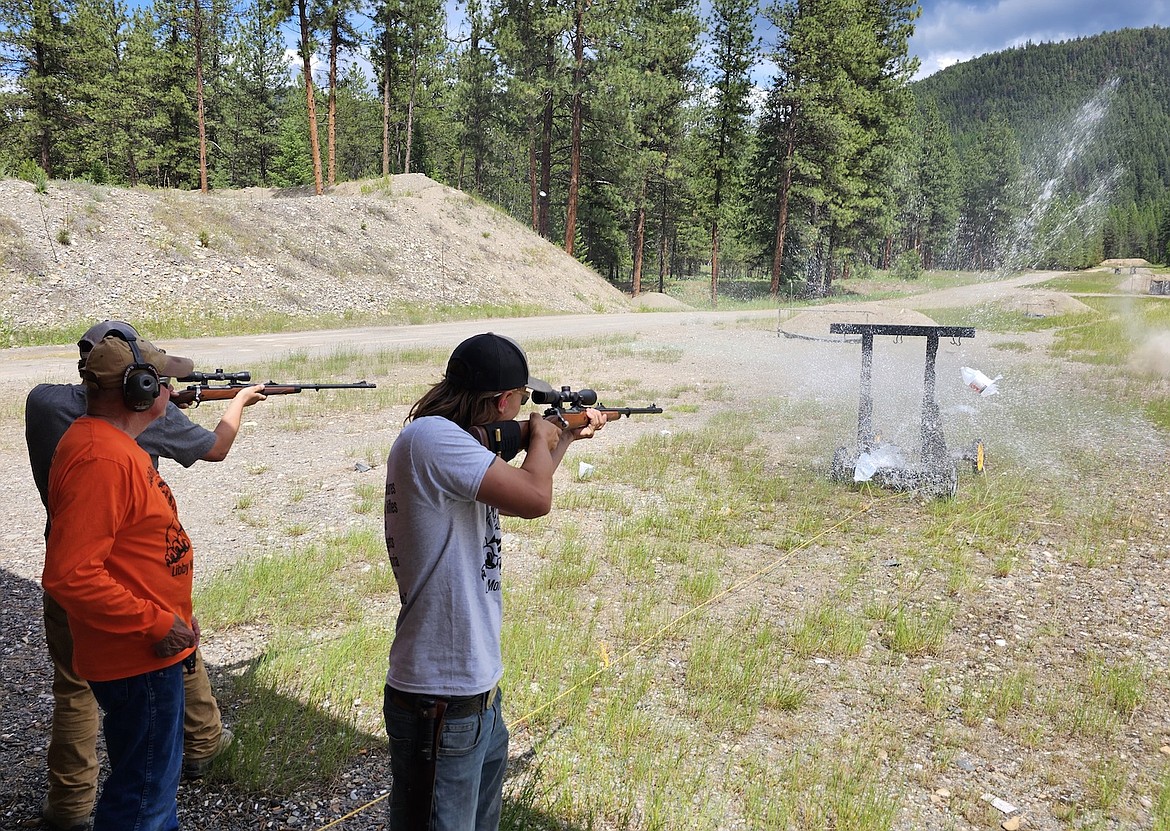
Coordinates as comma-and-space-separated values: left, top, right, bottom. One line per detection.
44, 595, 223, 825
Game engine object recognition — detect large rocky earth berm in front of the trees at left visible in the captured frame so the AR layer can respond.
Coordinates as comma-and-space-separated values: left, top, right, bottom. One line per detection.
0, 173, 628, 345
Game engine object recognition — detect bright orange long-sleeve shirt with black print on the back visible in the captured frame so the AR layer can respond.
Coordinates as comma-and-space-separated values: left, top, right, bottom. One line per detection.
41, 417, 194, 681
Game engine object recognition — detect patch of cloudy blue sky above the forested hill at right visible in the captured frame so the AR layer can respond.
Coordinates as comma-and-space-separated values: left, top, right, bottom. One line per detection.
910, 0, 1170, 77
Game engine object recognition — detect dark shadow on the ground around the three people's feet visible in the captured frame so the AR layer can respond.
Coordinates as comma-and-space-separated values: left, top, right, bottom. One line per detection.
0, 569, 577, 831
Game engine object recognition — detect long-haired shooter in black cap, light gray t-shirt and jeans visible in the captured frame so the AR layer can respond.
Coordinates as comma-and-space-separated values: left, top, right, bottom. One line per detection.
383, 332, 605, 831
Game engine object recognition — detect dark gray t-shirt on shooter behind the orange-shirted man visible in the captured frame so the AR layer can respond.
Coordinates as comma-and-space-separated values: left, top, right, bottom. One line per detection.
25, 384, 215, 533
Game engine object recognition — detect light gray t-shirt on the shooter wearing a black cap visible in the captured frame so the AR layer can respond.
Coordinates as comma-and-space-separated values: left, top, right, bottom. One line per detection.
386, 416, 504, 696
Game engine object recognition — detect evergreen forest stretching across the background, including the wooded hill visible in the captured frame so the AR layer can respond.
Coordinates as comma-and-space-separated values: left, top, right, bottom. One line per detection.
0, 0, 1170, 304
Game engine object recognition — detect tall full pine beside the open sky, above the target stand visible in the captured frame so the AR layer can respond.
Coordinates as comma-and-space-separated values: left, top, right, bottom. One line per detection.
769, 0, 917, 295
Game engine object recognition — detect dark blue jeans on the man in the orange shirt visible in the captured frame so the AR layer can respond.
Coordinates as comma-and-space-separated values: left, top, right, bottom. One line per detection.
89, 662, 184, 831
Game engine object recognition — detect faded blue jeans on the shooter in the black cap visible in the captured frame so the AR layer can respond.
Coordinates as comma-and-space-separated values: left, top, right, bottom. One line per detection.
383, 689, 508, 831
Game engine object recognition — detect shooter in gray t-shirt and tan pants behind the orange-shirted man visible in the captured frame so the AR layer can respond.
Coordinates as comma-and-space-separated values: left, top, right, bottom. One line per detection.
25, 321, 264, 831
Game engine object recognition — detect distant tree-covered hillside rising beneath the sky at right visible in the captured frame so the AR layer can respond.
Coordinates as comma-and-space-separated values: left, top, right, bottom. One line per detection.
914, 27, 1170, 271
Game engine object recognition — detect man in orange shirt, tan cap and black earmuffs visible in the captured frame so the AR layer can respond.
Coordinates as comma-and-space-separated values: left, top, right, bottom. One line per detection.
41, 334, 199, 831
